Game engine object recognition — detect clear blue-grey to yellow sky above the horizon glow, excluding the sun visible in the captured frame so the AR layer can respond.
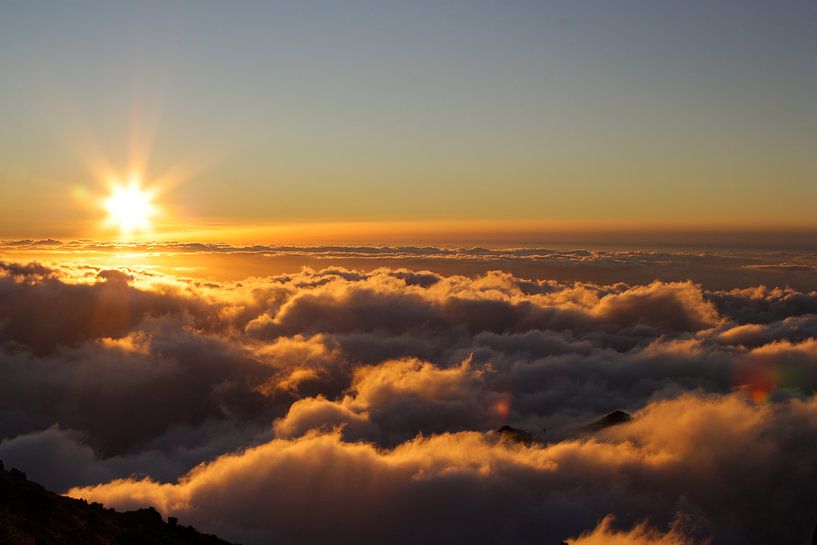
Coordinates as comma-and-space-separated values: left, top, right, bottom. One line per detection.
0, 0, 817, 237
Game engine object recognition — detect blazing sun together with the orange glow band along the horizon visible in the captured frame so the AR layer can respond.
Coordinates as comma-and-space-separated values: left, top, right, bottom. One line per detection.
14, 214, 817, 248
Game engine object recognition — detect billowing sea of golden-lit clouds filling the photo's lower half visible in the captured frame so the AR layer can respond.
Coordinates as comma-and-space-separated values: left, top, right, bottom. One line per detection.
0, 244, 817, 545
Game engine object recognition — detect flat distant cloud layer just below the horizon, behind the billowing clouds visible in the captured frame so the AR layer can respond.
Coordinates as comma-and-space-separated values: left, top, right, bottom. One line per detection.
0, 239, 817, 291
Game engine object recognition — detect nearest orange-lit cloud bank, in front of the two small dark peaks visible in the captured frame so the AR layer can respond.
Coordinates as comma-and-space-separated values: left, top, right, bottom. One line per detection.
70, 394, 817, 544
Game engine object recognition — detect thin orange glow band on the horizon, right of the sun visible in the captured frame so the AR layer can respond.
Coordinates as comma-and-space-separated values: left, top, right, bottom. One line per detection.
116, 216, 814, 247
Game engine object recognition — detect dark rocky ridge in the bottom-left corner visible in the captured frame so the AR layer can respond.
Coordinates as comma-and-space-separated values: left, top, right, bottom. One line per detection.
0, 462, 236, 545
